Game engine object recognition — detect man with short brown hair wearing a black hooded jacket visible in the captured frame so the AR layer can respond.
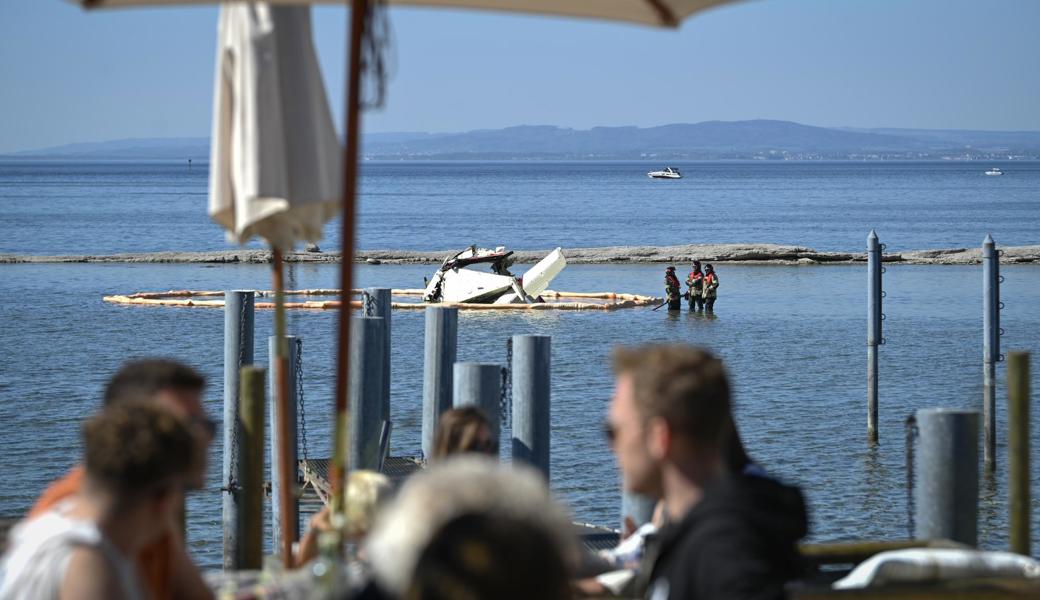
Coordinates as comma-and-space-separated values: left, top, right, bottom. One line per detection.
607, 345, 808, 600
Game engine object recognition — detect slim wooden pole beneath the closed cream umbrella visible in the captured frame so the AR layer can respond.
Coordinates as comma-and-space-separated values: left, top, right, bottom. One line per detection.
271, 246, 296, 569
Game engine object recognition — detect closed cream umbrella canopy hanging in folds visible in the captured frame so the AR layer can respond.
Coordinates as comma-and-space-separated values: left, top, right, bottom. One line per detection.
209, 2, 341, 251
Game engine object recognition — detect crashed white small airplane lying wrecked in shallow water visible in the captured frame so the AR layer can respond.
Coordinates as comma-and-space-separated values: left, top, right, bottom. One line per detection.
422, 245, 567, 305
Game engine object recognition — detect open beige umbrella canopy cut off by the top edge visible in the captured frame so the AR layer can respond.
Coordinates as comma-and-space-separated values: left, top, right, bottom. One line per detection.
80, 0, 733, 27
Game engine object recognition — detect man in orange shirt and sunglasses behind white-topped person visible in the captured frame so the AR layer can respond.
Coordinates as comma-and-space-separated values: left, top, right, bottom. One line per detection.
29, 359, 216, 600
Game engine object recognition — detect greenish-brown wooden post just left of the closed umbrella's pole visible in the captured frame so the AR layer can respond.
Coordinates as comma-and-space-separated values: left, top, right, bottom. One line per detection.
238, 366, 266, 569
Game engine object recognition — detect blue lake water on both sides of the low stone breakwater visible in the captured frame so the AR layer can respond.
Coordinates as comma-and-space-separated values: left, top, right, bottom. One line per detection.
0, 163, 1040, 568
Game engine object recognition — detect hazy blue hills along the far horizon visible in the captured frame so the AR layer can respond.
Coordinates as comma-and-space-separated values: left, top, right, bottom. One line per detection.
5, 120, 1040, 161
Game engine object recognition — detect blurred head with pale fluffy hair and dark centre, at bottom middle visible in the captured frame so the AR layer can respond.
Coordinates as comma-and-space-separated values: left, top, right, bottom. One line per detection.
367, 455, 577, 600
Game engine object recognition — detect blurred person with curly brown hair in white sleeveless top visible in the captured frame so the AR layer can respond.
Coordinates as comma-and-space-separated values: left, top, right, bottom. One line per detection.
0, 402, 199, 600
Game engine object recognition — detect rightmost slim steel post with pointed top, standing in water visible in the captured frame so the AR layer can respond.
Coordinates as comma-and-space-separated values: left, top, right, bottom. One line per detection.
982, 235, 1000, 471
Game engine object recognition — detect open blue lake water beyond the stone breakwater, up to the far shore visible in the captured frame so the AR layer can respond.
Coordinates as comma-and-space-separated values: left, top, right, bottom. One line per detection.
0, 161, 1040, 254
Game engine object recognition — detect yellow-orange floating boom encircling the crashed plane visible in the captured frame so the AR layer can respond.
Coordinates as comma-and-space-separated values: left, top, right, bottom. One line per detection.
102, 288, 661, 311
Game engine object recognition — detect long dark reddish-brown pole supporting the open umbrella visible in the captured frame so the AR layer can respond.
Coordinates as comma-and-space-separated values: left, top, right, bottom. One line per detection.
329, 0, 368, 515
